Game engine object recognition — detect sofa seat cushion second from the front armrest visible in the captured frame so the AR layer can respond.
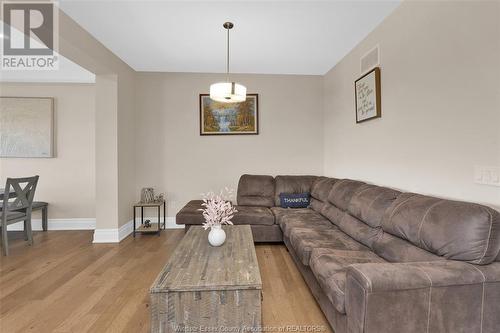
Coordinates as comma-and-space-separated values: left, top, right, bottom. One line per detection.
289, 224, 369, 266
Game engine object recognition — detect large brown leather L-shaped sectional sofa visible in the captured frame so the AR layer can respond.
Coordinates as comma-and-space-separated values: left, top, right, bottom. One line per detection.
177, 175, 500, 333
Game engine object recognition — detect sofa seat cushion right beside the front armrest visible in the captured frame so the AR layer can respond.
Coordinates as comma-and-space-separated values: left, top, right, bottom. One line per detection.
310, 248, 385, 314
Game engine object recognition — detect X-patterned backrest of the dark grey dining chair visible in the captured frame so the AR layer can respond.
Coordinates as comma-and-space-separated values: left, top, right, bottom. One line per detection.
3, 176, 38, 211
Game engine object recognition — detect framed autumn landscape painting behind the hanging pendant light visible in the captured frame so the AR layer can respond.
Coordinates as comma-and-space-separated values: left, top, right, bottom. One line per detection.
200, 94, 259, 135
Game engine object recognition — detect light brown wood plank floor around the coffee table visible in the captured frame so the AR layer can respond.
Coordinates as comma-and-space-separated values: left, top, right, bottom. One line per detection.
0, 230, 331, 333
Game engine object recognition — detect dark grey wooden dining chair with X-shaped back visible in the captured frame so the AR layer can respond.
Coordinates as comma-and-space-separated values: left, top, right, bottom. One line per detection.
0, 176, 38, 256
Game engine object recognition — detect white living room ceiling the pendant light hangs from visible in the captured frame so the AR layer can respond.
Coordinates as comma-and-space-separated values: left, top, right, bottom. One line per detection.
60, 0, 399, 74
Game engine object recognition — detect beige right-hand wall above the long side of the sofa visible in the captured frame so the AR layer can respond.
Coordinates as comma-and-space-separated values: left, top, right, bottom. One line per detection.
324, 1, 500, 206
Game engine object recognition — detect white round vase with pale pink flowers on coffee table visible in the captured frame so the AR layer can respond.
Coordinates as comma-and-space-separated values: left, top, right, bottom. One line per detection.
199, 187, 238, 246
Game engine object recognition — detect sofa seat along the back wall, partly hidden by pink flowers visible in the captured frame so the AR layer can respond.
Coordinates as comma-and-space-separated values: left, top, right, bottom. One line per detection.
176, 200, 274, 225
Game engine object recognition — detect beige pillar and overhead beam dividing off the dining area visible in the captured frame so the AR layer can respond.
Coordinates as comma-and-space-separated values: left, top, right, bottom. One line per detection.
59, 11, 135, 229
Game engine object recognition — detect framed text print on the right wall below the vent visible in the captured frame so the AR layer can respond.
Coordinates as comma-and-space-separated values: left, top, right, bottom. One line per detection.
354, 67, 382, 123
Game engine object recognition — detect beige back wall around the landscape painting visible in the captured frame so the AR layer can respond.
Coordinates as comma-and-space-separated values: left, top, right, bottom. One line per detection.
136, 73, 323, 216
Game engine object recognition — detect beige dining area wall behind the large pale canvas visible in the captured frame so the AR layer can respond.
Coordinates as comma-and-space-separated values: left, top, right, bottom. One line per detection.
0, 83, 95, 219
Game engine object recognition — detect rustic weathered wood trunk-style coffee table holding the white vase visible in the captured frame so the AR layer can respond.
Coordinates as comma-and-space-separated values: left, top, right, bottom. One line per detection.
150, 225, 262, 333
